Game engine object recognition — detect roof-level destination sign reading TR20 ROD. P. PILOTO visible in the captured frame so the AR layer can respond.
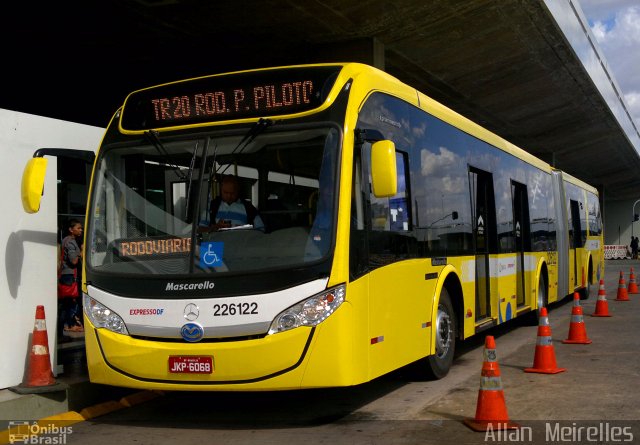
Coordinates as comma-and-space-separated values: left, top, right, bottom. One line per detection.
121, 66, 340, 131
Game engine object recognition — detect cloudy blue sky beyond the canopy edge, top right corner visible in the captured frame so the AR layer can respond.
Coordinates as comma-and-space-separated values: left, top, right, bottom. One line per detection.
579, 0, 640, 126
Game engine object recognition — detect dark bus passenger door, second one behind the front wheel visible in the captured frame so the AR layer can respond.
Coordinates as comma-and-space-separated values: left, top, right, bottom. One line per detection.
511, 181, 531, 306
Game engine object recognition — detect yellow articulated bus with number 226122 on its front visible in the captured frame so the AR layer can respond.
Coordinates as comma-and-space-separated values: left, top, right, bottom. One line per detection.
23, 63, 604, 391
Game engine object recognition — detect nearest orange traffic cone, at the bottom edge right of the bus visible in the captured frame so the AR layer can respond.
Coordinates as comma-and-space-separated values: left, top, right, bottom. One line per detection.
464, 335, 520, 431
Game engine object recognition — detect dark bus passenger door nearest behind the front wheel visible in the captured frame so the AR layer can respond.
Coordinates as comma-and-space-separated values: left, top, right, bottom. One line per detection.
469, 168, 496, 323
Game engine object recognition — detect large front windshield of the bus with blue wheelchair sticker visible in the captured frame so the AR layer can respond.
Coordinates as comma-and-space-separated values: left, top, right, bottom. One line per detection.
87, 123, 341, 275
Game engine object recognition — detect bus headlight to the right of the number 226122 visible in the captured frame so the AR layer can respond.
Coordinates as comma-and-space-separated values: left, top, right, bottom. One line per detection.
269, 284, 346, 334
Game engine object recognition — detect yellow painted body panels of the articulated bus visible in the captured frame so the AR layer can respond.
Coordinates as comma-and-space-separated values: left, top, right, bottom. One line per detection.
77, 64, 603, 391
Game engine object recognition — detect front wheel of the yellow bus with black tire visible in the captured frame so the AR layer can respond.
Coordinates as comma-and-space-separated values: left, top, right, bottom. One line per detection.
424, 288, 457, 379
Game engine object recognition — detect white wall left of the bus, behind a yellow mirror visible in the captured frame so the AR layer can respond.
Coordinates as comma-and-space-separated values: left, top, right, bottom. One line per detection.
0, 109, 104, 389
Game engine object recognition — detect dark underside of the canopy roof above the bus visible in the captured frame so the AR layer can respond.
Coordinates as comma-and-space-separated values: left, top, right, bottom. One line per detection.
6, 0, 640, 200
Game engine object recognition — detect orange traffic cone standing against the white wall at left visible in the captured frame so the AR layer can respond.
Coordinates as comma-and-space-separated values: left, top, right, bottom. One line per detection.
10, 305, 68, 394
